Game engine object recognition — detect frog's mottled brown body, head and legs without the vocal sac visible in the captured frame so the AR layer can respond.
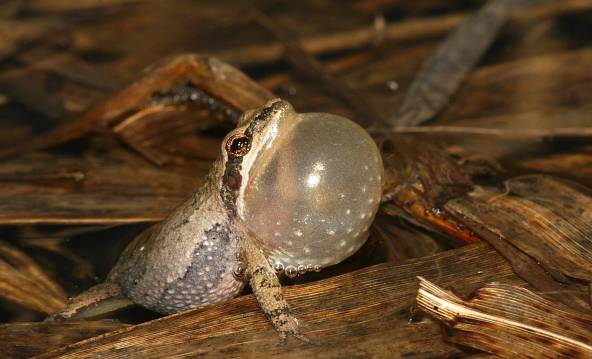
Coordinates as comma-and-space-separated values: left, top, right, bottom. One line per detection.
49, 100, 306, 340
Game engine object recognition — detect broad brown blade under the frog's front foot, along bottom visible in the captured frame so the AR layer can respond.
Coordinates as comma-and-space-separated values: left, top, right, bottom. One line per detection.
34, 245, 522, 358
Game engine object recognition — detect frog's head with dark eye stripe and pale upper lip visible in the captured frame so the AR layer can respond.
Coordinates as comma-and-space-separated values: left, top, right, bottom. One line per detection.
221, 99, 296, 215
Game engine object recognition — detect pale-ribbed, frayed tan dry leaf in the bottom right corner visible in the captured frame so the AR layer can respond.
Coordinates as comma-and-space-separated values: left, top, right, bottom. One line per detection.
417, 277, 592, 358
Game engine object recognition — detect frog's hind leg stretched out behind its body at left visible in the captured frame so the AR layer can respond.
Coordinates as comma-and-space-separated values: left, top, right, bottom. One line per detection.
46, 282, 133, 321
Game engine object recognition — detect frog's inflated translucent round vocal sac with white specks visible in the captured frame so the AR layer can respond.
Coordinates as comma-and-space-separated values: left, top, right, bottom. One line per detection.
241, 113, 383, 270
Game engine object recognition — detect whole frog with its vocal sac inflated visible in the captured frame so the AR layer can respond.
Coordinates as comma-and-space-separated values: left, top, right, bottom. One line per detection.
48, 99, 384, 342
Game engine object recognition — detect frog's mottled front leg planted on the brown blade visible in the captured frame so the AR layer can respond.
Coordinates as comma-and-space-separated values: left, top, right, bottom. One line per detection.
242, 240, 310, 343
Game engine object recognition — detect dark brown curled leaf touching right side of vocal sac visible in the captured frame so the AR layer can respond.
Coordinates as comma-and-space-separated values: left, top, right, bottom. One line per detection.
381, 135, 480, 243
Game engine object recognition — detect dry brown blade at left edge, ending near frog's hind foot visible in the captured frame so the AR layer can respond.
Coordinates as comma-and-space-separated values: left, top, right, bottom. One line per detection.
0, 242, 66, 313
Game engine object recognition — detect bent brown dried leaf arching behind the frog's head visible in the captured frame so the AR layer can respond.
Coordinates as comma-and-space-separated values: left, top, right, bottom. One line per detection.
0, 54, 274, 157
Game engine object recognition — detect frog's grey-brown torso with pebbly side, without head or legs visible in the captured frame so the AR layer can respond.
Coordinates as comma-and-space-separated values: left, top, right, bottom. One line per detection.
108, 187, 244, 313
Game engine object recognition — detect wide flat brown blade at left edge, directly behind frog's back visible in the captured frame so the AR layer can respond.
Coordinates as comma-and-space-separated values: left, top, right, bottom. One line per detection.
0, 146, 206, 224
